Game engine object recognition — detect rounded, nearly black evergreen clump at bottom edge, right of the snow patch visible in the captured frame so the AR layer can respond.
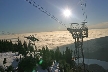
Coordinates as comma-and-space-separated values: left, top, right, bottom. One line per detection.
18, 56, 37, 72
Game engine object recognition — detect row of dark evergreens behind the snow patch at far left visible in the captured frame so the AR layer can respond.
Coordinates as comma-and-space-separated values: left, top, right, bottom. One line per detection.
0, 40, 34, 55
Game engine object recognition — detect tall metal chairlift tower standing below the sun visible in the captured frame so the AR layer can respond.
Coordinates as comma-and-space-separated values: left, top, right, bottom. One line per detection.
67, 22, 88, 72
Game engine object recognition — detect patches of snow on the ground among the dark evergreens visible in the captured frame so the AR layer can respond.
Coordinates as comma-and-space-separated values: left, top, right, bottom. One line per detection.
0, 52, 59, 72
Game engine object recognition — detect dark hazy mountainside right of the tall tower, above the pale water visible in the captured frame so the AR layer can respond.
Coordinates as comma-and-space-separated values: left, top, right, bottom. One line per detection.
84, 36, 108, 62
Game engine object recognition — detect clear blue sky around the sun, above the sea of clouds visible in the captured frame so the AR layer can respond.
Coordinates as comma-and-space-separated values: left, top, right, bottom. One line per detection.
0, 0, 108, 33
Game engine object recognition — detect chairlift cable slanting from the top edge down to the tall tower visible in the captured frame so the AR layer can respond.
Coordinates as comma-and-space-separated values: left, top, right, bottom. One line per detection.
26, 0, 67, 28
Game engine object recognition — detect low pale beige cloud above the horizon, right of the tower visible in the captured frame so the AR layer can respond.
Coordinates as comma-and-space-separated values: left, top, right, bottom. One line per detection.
88, 22, 108, 29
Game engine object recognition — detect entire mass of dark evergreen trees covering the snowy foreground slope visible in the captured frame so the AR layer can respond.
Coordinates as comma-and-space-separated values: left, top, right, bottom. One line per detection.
0, 40, 106, 72
